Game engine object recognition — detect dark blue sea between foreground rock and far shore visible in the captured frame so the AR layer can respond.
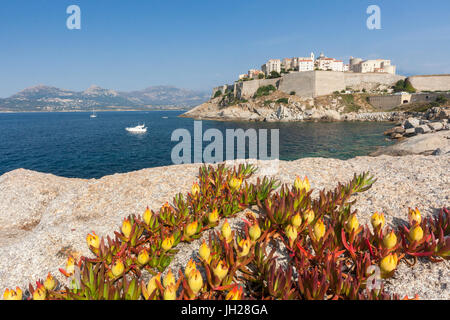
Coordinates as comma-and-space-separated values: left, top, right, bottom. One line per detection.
0, 111, 392, 178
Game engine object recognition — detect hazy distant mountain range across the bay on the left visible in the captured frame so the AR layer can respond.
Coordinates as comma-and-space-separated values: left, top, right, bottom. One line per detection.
0, 85, 210, 111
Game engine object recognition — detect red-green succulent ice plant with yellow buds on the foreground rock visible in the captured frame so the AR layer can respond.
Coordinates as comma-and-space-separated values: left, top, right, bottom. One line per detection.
3, 165, 450, 300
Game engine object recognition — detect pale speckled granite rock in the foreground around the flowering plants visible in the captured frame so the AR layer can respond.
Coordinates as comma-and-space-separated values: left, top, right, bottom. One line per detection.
0, 154, 450, 299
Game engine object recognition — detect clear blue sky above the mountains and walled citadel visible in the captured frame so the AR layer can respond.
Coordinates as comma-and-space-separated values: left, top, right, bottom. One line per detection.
0, 0, 450, 97
